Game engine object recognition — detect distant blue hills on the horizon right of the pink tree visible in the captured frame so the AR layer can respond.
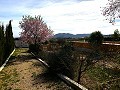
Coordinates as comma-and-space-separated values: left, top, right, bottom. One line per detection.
54, 33, 90, 38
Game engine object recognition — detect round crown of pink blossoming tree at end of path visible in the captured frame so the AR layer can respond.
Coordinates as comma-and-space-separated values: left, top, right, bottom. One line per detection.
19, 15, 53, 44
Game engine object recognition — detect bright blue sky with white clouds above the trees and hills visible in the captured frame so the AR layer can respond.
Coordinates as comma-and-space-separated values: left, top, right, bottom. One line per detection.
0, 0, 120, 37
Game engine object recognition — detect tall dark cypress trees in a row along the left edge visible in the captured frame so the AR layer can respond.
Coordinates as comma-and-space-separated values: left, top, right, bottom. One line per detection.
0, 21, 14, 66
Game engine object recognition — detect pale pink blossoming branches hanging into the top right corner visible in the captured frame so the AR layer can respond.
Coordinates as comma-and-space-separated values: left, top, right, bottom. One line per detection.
103, 0, 120, 24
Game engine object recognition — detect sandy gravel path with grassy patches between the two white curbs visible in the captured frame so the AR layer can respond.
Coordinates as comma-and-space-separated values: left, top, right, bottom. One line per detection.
0, 50, 71, 90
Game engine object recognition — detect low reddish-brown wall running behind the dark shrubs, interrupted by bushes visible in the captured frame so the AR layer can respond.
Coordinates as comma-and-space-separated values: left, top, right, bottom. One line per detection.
40, 42, 120, 53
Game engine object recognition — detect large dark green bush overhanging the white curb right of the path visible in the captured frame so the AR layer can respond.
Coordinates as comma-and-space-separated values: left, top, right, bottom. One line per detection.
39, 43, 74, 78
